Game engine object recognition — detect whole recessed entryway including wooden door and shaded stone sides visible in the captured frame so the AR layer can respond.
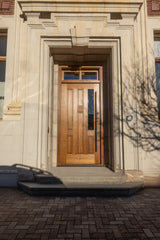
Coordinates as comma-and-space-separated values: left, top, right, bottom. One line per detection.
48, 44, 121, 170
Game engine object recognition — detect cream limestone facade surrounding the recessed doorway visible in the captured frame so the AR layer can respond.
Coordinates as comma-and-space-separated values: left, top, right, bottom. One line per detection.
0, 0, 160, 185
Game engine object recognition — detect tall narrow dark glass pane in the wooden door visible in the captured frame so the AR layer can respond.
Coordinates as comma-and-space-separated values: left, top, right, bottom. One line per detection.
88, 89, 94, 130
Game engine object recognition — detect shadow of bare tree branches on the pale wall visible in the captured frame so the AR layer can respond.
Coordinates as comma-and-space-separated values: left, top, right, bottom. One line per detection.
115, 64, 160, 152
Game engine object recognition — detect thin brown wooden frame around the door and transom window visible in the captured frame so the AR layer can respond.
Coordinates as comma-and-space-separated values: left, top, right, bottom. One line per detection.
57, 65, 104, 166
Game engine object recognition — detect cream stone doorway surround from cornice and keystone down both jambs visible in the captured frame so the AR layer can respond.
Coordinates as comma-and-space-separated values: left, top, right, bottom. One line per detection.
18, 0, 143, 170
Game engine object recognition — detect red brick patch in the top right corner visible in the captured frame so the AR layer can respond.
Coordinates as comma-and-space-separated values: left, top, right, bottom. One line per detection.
147, 0, 160, 16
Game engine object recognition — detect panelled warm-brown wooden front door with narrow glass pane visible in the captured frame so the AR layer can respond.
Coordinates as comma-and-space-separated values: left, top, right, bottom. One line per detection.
58, 67, 100, 165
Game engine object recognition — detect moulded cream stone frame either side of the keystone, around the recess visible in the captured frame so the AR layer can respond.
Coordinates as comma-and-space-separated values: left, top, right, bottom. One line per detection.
37, 36, 122, 171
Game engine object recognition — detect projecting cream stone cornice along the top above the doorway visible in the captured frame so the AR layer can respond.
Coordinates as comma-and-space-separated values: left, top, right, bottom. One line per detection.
18, 0, 143, 15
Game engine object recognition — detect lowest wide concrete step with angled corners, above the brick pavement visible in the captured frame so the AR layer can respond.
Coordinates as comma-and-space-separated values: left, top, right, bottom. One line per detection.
18, 182, 143, 197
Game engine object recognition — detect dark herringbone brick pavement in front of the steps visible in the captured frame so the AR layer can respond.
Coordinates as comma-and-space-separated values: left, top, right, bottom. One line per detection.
0, 189, 160, 240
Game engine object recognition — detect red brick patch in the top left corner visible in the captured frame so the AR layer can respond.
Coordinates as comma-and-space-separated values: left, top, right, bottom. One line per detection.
0, 0, 15, 15
